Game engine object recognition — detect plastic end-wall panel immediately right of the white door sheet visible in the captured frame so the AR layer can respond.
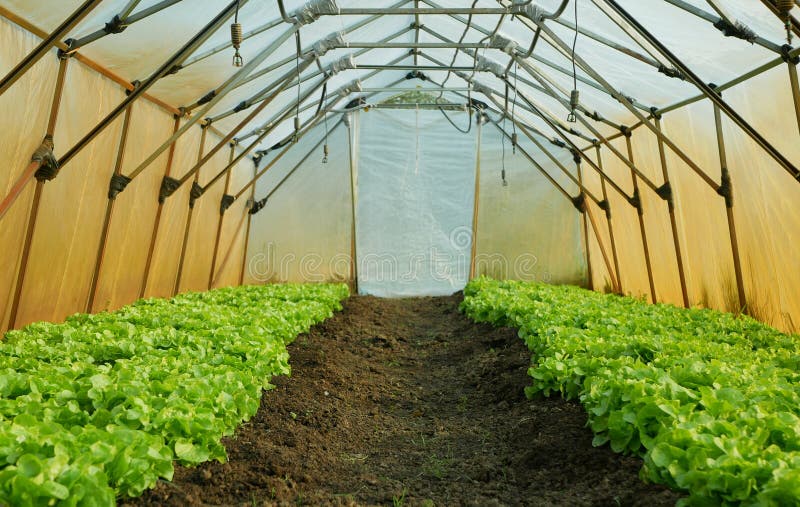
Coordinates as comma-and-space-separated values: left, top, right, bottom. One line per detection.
475, 121, 586, 285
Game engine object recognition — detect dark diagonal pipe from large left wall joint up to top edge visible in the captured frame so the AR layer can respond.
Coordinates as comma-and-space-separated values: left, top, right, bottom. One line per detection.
58, 0, 248, 171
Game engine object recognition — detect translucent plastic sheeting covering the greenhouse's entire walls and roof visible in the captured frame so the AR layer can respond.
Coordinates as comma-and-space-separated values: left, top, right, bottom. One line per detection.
0, 0, 800, 329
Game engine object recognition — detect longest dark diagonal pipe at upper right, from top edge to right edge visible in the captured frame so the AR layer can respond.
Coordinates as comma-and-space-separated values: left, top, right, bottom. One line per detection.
602, 0, 800, 180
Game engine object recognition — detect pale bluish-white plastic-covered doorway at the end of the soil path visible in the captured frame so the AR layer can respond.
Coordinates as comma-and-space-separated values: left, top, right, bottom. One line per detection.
356, 110, 479, 297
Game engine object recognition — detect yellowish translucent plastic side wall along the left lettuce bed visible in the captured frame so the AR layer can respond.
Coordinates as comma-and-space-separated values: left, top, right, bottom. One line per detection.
0, 18, 252, 330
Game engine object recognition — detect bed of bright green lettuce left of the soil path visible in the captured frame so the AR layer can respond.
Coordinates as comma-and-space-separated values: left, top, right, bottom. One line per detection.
0, 285, 348, 506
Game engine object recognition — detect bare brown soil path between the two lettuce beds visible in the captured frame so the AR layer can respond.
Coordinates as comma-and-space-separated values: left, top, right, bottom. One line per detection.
127, 296, 680, 507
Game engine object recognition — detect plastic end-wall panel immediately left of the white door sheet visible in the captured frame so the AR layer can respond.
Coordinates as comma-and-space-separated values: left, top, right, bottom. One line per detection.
245, 122, 352, 283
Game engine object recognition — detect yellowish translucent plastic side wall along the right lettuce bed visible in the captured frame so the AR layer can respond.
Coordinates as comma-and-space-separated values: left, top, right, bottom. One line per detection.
584, 66, 800, 331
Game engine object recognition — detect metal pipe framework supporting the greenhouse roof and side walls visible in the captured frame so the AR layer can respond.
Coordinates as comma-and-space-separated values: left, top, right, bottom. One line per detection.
0, 0, 800, 326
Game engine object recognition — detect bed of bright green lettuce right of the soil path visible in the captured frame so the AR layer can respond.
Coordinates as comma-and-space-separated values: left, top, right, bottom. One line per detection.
462, 278, 800, 506
